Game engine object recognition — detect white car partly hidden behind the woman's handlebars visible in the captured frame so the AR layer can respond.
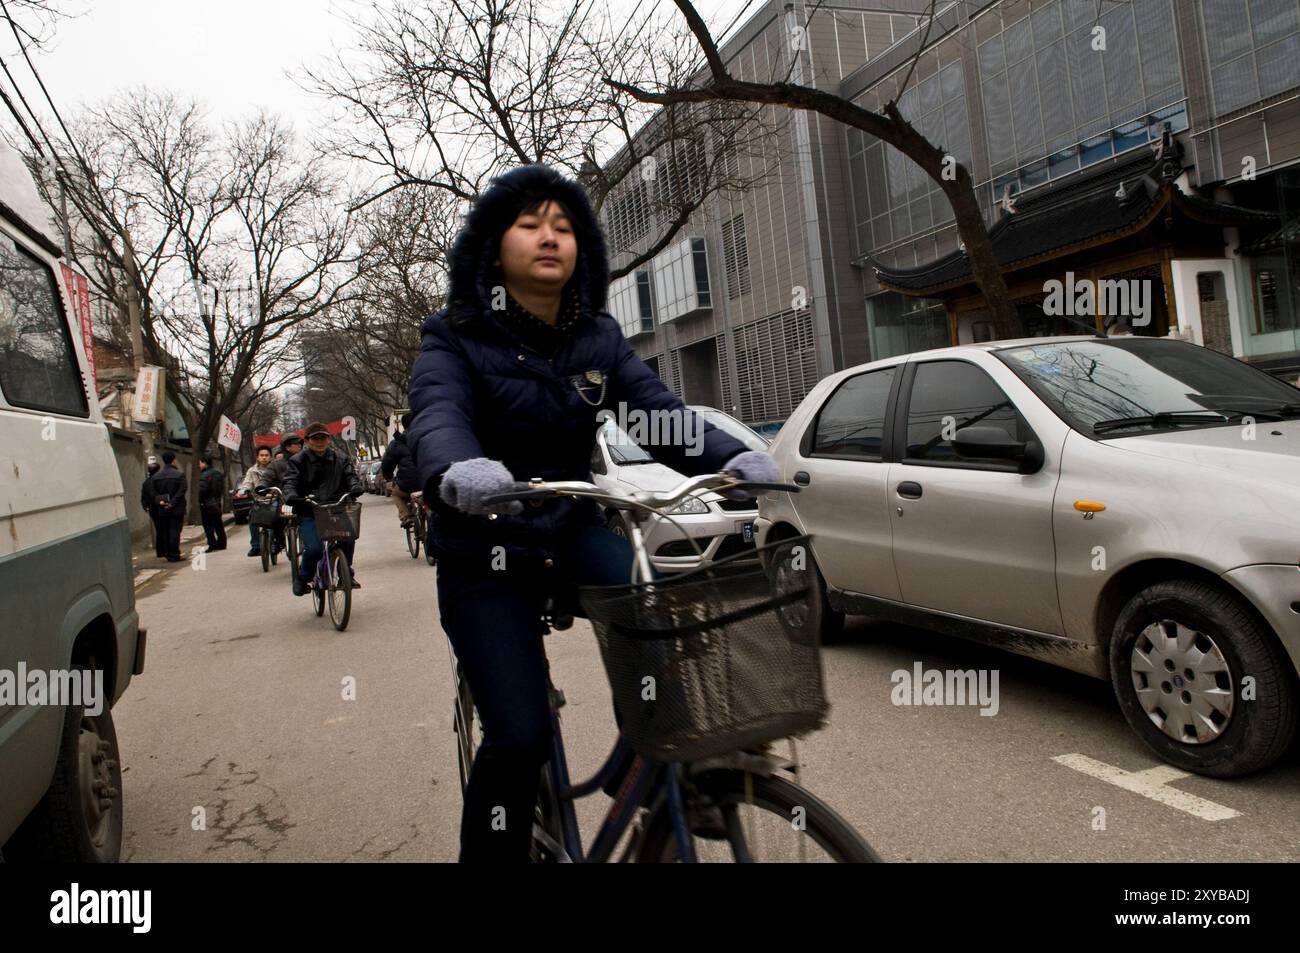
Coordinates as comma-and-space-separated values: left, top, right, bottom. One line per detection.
592, 407, 768, 572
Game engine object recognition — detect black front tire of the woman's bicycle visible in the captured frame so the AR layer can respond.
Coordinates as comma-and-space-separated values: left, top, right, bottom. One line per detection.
637, 768, 880, 863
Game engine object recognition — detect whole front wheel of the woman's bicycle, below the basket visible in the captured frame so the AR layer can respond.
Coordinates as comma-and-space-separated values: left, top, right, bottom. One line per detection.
637, 770, 880, 863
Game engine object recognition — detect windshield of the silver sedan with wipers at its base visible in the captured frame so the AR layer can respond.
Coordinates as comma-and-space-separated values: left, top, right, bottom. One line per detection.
995, 338, 1300, 437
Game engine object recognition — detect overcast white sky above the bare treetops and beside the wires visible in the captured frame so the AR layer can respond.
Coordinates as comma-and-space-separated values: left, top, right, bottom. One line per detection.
0, 0, 759, 139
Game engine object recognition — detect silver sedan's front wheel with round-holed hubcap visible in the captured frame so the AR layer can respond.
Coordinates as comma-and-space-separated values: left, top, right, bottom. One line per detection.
1110, 580, 1296, 777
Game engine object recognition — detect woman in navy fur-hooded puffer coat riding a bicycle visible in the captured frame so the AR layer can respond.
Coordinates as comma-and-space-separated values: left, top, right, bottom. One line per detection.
407, 165, 777, 862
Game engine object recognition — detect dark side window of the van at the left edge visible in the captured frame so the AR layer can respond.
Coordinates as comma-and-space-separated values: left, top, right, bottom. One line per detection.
0, 234, 88, 417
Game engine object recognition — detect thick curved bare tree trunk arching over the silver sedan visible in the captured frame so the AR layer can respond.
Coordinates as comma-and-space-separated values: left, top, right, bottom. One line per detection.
605, 0, 1022, 338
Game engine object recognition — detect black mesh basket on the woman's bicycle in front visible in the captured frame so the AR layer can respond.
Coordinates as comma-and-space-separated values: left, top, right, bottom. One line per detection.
579, 537, 829, 762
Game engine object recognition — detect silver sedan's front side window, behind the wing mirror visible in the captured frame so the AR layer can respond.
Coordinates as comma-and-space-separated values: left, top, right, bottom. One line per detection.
904, 360, 1030, 463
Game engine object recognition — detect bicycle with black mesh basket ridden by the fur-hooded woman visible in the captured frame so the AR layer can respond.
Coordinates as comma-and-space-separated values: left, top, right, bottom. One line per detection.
449, 473, 880, 863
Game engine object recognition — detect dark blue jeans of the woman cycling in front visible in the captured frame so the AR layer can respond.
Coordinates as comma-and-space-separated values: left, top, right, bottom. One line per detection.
438, 525, 632, 863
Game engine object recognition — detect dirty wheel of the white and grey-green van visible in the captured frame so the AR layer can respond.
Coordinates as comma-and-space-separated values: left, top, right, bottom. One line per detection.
4, 667, 122, 863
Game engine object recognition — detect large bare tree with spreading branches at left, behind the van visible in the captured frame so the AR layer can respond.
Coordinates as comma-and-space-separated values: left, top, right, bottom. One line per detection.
36, 90, 355, 512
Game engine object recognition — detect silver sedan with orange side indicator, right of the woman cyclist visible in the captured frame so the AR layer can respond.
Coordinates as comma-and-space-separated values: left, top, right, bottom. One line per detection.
758, 337, 1300, 777
